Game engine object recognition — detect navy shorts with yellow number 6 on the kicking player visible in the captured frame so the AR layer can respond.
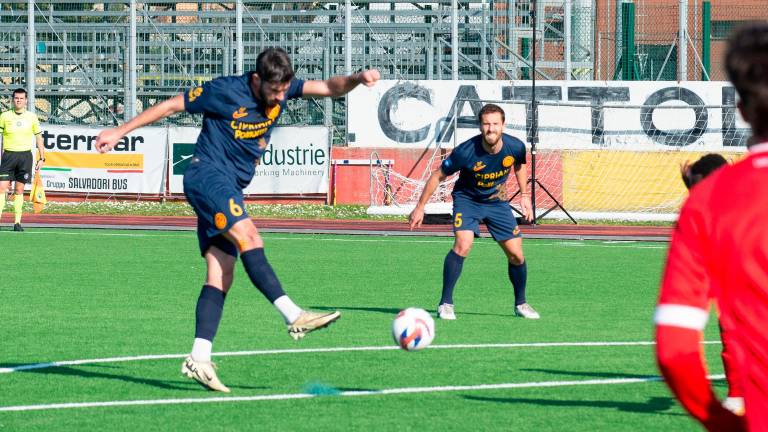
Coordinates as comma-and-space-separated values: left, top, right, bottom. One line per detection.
184, 159, 248, 257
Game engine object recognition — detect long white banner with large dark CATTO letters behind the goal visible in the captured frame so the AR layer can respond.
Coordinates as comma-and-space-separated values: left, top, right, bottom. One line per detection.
348, 80, 749, 151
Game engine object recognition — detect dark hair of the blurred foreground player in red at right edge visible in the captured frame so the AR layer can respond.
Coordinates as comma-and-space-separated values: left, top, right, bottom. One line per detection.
725, 22, 768, 138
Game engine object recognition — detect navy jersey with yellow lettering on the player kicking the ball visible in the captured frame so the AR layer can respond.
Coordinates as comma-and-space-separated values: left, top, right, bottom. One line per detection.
184, 72, 304, 189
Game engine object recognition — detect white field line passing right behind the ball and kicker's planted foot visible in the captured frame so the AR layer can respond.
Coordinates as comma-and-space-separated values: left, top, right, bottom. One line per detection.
0, 340, 720, 374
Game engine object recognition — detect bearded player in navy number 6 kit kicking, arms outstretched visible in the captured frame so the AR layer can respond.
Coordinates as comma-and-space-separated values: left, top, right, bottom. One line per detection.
96, 48, 380, 392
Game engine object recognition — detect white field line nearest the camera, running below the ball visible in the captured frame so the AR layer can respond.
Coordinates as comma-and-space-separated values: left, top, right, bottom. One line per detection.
0, 375, 725, 412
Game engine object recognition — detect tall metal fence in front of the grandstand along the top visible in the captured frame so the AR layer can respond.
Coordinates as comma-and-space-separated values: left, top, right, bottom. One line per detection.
0, 0, 768, 144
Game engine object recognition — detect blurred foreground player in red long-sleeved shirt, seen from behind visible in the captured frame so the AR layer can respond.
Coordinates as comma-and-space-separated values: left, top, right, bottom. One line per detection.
654, 22, 768, 431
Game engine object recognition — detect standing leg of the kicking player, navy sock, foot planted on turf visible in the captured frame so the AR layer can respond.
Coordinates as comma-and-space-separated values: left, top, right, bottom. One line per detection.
181, 246, 236, 393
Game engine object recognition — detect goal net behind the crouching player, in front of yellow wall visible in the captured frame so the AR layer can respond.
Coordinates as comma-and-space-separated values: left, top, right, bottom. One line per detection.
369, 101, 747, 220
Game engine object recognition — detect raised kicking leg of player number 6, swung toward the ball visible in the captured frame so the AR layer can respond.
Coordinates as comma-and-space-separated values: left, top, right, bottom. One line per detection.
225, 219, 341, 340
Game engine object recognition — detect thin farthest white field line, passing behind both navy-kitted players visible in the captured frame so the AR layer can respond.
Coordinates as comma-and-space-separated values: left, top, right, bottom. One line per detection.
0, 230, 667, 249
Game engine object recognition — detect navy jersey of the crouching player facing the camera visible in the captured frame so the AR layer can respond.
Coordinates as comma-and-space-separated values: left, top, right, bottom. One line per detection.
440, 134, 525, 202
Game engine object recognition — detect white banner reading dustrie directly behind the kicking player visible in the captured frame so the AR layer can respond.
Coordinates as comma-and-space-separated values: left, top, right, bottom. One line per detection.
168, 126, 330, 195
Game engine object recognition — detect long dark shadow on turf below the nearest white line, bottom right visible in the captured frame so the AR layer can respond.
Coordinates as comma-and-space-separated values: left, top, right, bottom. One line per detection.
462, 395, 685, 416
